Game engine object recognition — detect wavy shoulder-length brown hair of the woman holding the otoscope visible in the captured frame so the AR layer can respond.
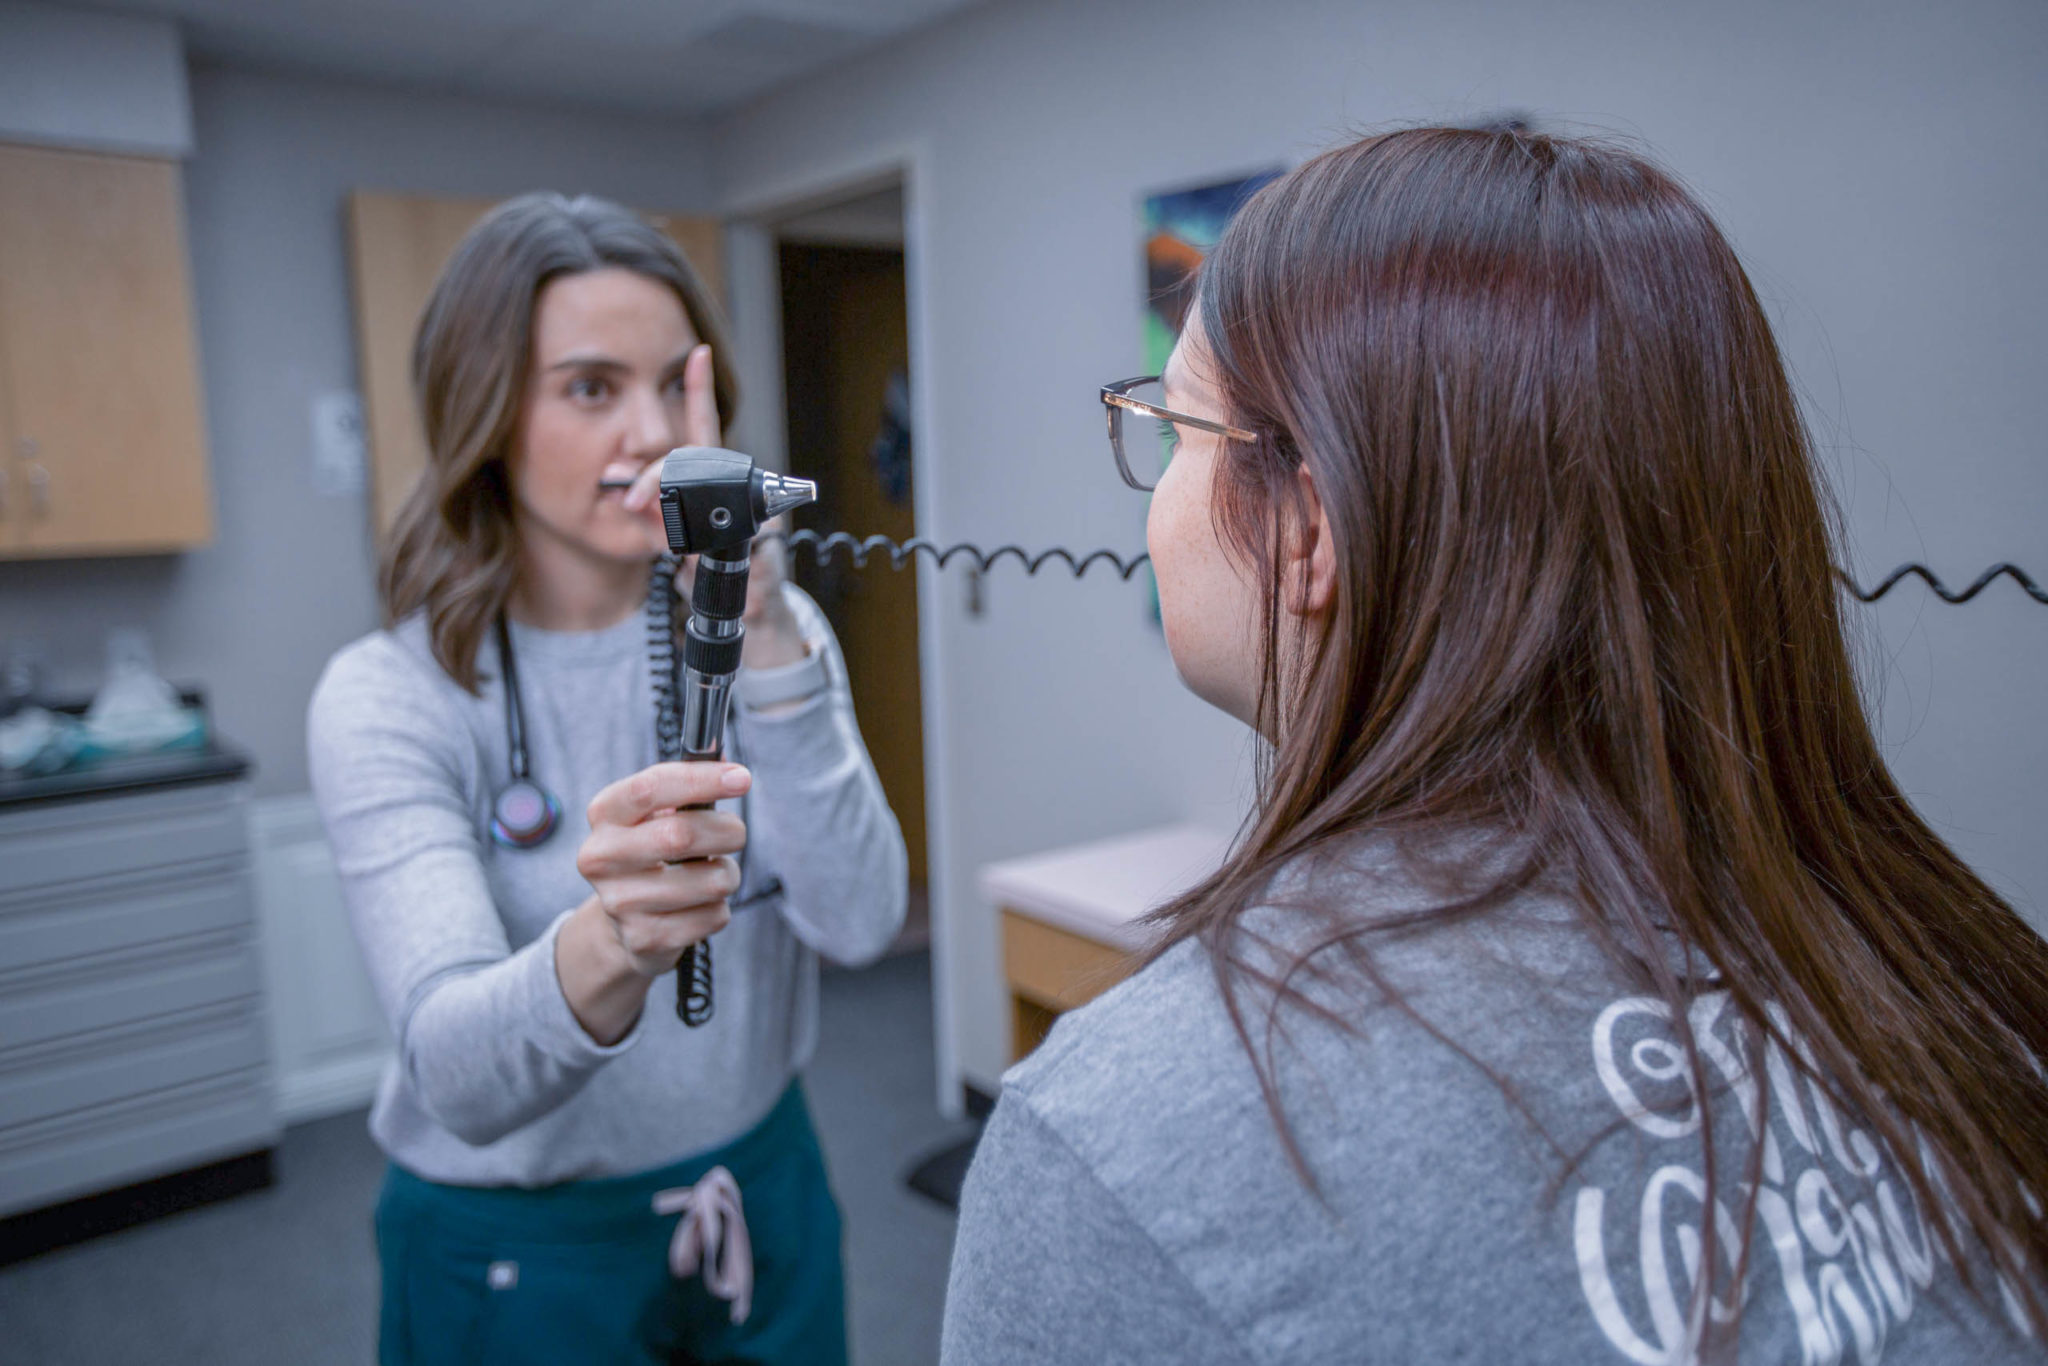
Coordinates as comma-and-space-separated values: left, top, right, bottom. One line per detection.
377, 195, 739, 692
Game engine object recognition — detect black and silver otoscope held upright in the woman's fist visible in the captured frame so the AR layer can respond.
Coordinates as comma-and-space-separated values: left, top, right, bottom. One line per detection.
647, 446, 817, 1026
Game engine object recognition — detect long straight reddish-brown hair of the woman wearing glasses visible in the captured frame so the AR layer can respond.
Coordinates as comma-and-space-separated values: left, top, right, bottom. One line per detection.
1157, 127, 2048, 1325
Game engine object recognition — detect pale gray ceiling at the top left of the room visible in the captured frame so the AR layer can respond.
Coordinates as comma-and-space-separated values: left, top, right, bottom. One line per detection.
61, 0, 979, 115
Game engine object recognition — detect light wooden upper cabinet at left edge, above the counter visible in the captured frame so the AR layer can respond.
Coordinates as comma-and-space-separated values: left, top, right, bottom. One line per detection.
0, 145, 213, 555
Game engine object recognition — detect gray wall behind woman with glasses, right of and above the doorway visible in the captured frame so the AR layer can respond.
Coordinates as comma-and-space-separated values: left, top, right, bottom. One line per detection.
713, 0, 2048, 1083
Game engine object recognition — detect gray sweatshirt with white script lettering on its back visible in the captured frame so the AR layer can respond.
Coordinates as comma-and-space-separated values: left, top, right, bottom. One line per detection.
942, 850, 2042, 1366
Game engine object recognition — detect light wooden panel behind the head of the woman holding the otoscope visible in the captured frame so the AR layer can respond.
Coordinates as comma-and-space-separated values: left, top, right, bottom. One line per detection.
348, 190, 725, 535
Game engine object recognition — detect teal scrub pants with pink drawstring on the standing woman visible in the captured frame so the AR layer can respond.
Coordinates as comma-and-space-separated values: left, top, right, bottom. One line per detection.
377, 1081, 846, 1366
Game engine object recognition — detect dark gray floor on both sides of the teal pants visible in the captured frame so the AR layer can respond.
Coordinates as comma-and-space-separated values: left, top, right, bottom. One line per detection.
0, 952, 967, 1366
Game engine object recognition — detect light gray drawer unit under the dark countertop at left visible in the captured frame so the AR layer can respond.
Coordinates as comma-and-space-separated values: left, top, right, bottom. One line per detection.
0, 780, 279, 1219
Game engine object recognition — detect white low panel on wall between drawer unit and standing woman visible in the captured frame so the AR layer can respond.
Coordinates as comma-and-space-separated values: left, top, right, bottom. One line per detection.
250, 793, 391, 1124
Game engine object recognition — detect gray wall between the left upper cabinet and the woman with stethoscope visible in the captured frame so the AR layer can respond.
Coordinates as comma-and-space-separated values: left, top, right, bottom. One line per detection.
0, 68, 707, 793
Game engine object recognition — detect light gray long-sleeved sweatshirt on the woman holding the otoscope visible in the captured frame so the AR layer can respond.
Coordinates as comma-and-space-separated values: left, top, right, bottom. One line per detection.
307, 588, 905, 1186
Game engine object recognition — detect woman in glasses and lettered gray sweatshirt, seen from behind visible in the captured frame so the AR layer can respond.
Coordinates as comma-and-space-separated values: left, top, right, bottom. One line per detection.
944, 129, 2048, 1366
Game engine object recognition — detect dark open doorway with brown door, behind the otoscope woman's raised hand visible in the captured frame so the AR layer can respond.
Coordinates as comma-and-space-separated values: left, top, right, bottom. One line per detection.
770, 180, 932, 948
